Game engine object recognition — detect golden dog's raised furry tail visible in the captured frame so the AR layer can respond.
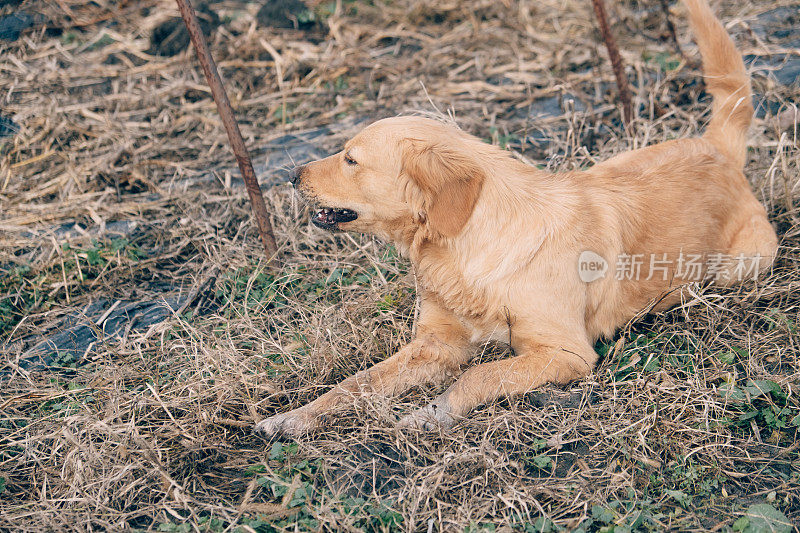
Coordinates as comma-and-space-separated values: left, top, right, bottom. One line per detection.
683, 0, 753, 168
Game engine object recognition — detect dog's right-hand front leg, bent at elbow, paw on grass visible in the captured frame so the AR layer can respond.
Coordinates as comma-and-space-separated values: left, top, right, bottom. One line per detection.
400, 342, 597, 429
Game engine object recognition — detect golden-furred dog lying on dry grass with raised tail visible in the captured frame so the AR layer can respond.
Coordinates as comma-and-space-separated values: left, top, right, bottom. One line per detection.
255, 0, 778, 438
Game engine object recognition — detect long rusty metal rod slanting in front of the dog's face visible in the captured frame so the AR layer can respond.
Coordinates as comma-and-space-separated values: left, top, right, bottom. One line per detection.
175, 0, 278, 261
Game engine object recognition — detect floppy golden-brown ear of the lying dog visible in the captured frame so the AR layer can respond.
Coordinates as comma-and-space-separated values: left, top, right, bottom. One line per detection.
403, 141, 486, 237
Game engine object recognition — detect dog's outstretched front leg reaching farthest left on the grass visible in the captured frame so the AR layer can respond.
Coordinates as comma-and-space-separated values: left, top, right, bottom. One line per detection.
254, 297, 472, 438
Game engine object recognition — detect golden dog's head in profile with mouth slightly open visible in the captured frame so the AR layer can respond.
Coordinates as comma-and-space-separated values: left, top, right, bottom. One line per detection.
292, 117, 486, 243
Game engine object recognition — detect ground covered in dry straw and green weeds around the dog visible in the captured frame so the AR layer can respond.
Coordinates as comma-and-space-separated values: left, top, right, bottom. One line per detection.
0, 0, 800, 532
